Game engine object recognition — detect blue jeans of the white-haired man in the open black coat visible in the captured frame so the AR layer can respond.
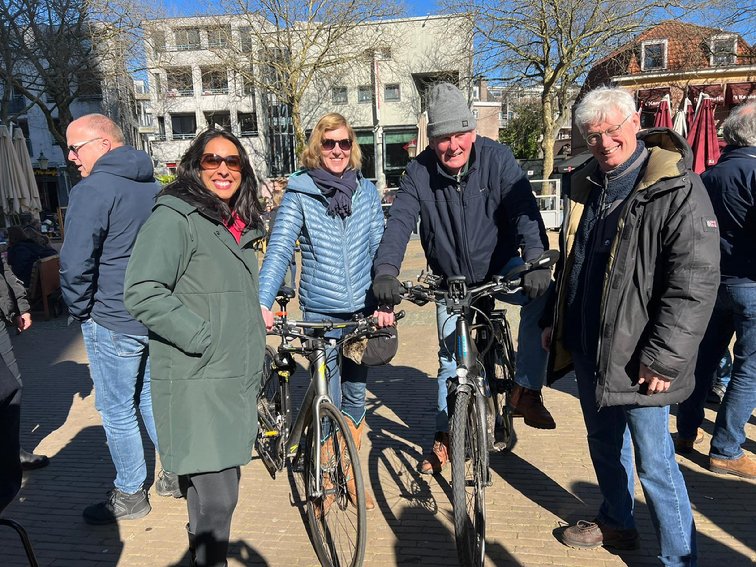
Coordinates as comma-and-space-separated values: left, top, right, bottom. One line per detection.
573, 353, 696, 566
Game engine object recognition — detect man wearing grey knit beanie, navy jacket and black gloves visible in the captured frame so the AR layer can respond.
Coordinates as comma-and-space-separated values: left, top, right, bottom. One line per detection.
373, 83, 556, 474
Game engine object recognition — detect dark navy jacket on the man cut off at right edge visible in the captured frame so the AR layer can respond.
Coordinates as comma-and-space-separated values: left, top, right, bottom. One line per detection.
701, 146, 756, 281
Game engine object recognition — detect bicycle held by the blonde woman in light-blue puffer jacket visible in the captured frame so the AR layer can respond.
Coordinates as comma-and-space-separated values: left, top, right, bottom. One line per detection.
257, 288, 402, 567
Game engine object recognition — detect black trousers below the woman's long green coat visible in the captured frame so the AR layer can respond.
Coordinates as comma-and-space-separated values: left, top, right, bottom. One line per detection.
182, 467, 240, 567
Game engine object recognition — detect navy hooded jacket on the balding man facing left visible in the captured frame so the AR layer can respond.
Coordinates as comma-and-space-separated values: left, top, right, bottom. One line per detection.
60, 146, 159, 335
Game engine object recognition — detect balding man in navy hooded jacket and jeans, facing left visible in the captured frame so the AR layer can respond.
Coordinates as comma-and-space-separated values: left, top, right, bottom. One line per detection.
60, 114, 170, 525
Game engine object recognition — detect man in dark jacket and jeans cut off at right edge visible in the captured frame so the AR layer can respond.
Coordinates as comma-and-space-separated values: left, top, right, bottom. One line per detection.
676, 102, 756, 478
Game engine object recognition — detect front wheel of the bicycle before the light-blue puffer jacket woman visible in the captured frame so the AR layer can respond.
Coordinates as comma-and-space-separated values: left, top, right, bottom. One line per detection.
304, 402, 367, 567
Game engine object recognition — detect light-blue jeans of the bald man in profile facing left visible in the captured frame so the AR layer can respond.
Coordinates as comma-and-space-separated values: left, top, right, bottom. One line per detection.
81, 318, 157, 494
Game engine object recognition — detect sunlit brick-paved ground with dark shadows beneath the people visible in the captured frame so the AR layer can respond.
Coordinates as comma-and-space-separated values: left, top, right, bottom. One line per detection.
0, 242, 756, 567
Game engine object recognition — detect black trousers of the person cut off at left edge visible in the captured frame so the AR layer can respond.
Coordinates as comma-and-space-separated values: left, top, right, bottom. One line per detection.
0, 323, 22, 511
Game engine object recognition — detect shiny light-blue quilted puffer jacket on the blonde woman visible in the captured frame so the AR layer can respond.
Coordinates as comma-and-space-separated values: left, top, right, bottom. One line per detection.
260, 170, 383, 313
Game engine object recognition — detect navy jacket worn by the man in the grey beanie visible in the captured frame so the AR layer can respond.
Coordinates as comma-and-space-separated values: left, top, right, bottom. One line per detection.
374, 136, 548, 284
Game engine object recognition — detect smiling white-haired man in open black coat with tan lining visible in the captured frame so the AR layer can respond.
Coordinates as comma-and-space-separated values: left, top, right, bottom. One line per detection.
543, 88, 719, 565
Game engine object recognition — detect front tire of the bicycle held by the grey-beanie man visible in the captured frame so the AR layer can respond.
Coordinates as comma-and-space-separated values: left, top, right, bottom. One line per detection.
450, 390, 488, 566
